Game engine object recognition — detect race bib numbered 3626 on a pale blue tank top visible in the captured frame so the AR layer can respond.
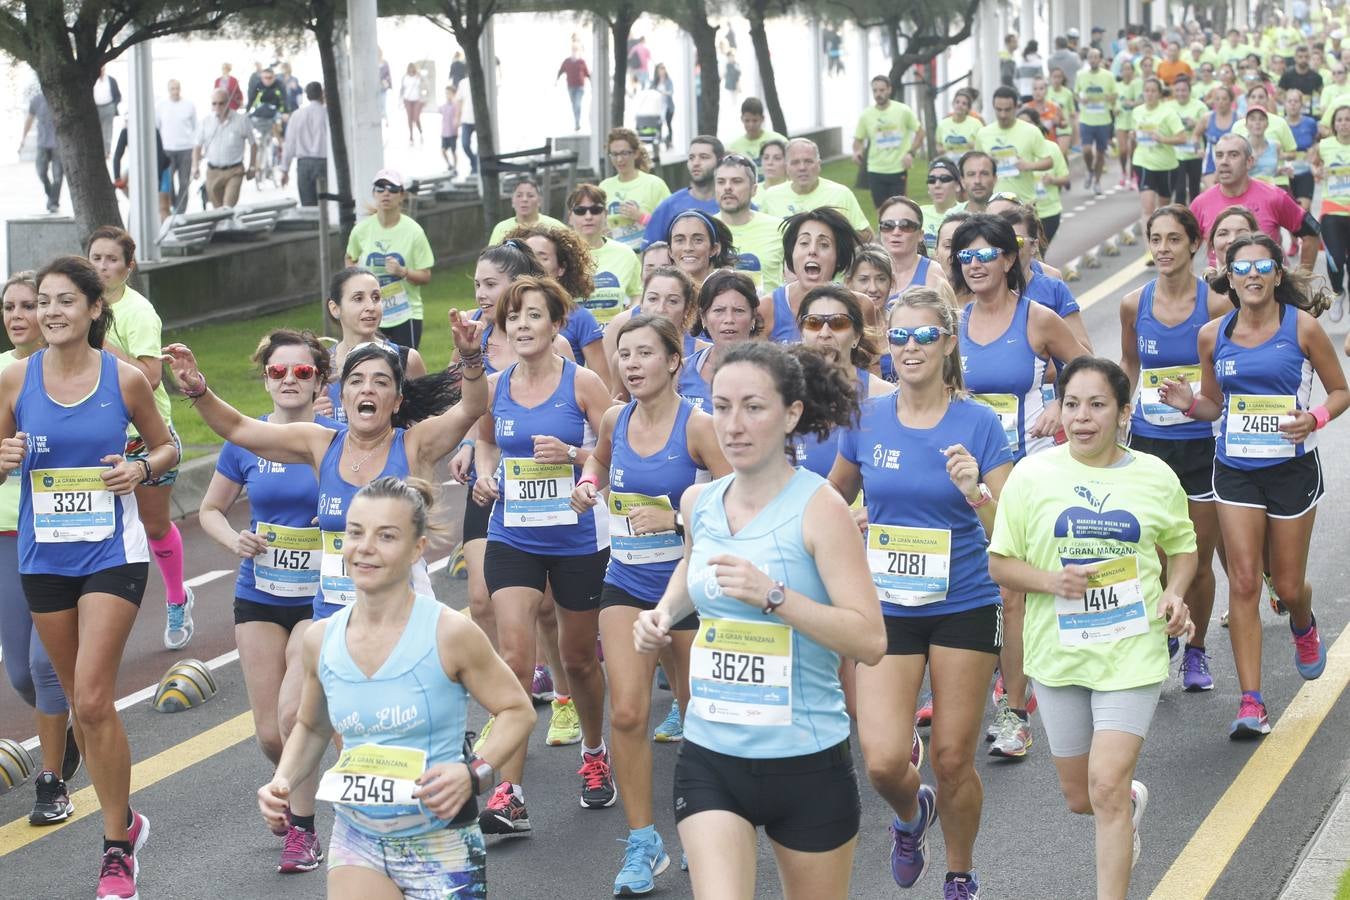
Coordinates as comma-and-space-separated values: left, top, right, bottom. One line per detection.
689, 619, 792, 727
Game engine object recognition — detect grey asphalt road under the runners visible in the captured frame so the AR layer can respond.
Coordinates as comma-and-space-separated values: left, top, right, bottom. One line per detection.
0, 175, 1350, 900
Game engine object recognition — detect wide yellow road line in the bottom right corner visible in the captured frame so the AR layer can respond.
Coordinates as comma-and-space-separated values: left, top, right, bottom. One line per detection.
1149, 630, 1350, 900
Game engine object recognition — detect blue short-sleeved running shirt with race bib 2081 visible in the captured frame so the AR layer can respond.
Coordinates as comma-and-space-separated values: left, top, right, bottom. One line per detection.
838, 394, 1013, 617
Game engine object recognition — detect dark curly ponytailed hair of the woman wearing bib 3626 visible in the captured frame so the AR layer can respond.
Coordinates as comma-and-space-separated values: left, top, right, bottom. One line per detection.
711, 340, 859, 440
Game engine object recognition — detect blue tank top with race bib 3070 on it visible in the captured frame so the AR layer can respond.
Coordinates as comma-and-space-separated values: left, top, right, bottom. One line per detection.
487, 359, 609, 556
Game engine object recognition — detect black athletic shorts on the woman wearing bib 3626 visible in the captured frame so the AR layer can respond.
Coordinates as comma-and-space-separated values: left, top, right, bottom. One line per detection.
675, 738, 863, 853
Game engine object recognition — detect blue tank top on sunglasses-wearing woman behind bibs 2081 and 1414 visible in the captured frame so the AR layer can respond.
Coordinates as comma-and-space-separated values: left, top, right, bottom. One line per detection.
961, 297, 1054, 460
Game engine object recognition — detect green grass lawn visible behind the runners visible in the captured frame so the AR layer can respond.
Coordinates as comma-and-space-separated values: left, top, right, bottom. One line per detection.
165, 158, 927, 459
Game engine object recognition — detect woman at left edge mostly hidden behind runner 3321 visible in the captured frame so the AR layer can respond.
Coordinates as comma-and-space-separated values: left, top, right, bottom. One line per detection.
0, 271, 80, 824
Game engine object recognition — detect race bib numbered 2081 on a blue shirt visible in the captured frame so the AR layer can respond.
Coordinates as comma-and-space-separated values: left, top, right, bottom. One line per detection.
867, 524, 952, 606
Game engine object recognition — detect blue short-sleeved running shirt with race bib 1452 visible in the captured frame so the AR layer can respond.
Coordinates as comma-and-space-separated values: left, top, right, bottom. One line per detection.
216, 416, 342, 606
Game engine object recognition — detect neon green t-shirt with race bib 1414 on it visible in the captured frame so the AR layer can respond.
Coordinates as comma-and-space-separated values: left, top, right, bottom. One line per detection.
990, 447, 1195, 691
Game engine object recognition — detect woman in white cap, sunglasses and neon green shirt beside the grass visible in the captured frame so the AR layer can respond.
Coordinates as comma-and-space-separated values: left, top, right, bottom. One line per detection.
344, 167, 432, 349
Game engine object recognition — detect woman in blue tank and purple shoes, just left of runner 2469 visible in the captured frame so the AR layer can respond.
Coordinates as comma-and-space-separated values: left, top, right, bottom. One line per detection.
1121, 205, 1231, 692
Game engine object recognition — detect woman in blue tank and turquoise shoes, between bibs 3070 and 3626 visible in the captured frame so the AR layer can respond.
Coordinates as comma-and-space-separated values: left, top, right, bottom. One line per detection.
572, 313, 730, 896
